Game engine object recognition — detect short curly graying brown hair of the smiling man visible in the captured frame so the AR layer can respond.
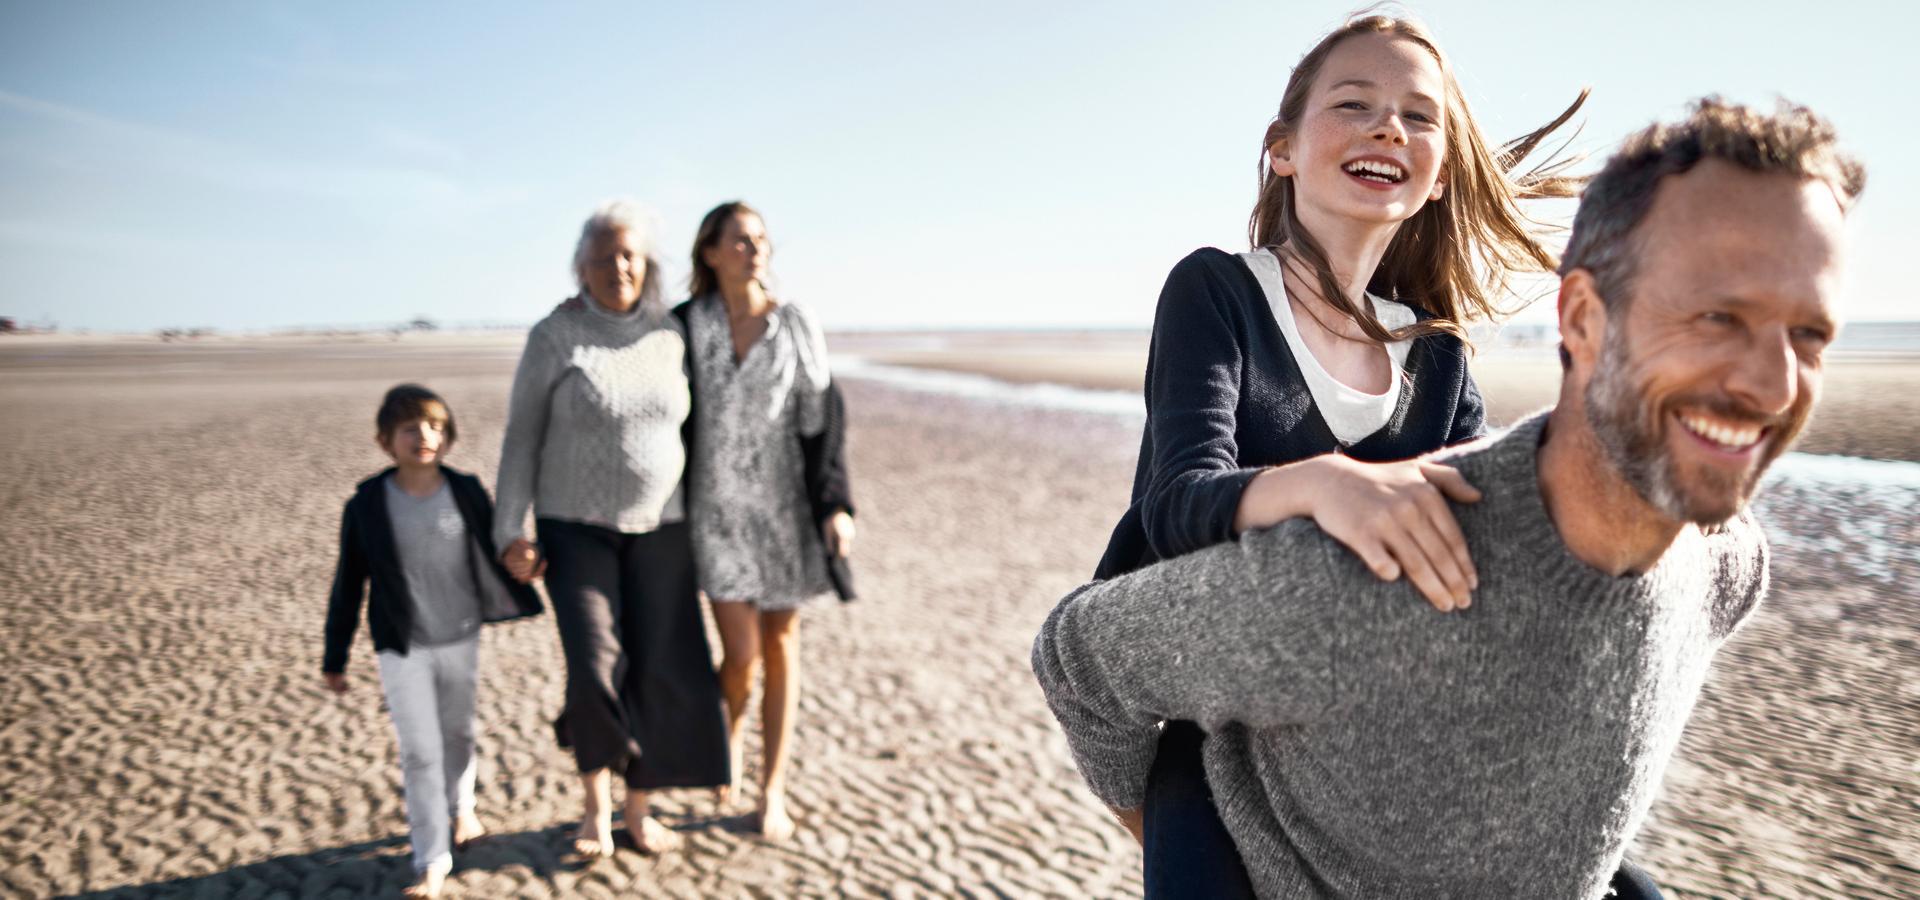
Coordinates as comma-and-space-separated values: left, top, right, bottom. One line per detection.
1559, 96, 1866, 309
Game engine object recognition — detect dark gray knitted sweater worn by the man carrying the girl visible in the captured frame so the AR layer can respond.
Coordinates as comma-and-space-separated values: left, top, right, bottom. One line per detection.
1033, 414, 1766, 898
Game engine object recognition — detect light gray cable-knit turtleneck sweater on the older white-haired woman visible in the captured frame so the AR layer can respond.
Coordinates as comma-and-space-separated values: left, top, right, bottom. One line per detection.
493, 296, 691, 549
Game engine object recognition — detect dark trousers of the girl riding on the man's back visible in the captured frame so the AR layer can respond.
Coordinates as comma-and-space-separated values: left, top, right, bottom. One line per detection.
1144, 722, 1661, 900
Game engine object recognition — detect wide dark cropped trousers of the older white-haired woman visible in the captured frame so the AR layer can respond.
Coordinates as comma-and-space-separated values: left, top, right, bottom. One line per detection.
536, 518, 728, 791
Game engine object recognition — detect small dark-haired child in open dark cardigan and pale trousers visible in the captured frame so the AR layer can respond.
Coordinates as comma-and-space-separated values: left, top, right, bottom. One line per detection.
321, 384, 541, 896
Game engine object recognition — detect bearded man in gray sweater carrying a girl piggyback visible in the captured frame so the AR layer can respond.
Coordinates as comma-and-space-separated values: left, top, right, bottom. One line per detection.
1033, 100, 1864, 898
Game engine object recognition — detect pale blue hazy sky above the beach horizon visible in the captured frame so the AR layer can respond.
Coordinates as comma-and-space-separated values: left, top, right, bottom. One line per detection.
0, 0, 1920, 330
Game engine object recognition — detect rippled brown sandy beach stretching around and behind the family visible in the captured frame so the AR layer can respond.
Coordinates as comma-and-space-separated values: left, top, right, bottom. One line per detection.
0, 334, 1920, 898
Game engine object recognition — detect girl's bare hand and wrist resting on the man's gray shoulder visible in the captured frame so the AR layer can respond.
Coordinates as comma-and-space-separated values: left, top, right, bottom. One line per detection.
1235, 453, 1480, 612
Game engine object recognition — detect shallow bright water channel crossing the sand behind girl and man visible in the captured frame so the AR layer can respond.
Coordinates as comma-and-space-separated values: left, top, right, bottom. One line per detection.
833, 351, 1920, 593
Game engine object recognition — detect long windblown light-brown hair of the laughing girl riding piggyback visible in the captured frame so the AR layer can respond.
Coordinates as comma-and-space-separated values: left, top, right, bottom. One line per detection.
1246, 15, 1588, 343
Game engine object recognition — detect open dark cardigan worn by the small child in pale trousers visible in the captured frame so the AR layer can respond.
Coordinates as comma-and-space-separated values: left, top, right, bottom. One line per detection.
321, 466, 541, 672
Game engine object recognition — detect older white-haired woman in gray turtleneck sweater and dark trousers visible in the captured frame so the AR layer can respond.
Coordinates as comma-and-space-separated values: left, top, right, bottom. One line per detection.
493, 201, 730, 856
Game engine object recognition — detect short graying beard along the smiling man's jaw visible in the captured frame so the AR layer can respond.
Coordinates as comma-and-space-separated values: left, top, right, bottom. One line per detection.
1586, 334, 1751, 526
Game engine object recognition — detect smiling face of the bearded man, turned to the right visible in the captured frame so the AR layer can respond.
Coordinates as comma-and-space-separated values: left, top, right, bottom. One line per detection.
1586, 159, 1843, 524
